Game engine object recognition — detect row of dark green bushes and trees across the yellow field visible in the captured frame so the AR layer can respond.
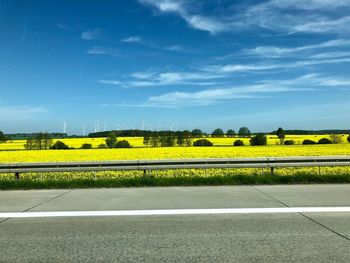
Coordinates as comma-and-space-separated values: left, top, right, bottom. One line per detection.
0, 127, 350, 150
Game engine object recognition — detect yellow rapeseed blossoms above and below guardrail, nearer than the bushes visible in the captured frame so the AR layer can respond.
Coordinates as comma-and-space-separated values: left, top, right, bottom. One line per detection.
0, 143, 350, 182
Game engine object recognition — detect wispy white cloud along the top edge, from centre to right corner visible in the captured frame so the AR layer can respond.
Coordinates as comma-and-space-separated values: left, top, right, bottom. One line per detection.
139, 0, 350, 34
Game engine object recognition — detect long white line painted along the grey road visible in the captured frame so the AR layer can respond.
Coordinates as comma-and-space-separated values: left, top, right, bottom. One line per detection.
0, 206, 350, 218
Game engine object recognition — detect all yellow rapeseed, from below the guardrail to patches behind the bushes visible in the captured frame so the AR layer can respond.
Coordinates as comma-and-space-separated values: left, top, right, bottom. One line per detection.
0, 136, 350, 189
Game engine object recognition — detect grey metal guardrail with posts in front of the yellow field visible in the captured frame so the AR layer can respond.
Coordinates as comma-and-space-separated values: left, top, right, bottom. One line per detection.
0, 155, 350, 179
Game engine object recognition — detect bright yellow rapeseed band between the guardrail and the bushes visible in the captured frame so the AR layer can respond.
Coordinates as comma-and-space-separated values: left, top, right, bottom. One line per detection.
0, 144, 350, 163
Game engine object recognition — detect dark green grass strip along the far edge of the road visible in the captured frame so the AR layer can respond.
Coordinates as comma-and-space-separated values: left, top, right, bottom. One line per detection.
0, 174, 350, 190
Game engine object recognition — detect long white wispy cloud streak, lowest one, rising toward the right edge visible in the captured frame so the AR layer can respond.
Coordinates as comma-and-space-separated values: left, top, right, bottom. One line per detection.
103, 74, 350, 108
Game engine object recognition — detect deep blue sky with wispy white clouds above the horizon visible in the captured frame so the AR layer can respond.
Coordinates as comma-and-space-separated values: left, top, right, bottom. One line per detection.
0, 0, 350, 134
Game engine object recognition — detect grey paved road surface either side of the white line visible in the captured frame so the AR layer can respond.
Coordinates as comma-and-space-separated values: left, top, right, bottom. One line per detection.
0, 185, 350, 262
